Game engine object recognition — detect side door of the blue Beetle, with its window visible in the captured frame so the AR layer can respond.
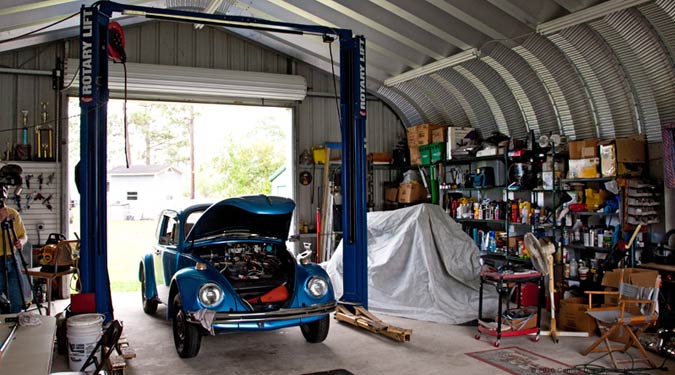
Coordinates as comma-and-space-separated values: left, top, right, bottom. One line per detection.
152, 211, 179, 303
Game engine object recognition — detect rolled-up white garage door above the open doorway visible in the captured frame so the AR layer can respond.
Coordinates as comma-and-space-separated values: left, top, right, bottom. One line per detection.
65, 59, 307, 100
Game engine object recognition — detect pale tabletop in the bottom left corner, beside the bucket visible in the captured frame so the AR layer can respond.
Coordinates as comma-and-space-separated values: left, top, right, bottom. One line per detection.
0, 314, 56, 375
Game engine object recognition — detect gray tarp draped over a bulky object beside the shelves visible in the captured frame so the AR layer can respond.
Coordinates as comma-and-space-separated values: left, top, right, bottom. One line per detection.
323, 204, 497, 324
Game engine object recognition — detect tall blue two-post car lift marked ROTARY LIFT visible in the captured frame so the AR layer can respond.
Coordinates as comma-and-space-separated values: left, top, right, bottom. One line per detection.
79, 1, 368, 320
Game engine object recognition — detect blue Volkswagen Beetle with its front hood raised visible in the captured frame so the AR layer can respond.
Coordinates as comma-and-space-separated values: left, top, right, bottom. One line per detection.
139, 195, 336, 358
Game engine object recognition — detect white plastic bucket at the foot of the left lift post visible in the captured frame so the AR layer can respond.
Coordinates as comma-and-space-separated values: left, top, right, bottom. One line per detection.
66, 314, 104, 371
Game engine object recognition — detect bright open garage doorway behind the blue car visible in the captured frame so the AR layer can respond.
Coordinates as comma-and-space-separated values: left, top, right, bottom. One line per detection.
68, 97, 293, 292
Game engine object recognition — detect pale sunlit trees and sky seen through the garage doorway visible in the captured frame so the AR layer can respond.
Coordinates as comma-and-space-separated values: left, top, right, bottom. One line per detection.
68, 98, 291, 200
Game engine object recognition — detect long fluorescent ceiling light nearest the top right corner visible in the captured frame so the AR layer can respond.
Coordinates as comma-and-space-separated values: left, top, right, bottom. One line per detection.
537, 0, 652, 35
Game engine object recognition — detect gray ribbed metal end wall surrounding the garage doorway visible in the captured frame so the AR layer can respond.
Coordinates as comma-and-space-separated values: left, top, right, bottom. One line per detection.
0, 22, 405, 238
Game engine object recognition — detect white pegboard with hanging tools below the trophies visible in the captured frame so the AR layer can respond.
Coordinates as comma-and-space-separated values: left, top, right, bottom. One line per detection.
2, 161, 62, 250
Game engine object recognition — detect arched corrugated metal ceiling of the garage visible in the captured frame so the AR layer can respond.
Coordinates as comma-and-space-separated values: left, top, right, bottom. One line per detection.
0, 0, 675, 142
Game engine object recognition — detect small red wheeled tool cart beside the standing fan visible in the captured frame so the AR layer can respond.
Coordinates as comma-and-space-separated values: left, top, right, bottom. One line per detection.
474, 271, 546, 347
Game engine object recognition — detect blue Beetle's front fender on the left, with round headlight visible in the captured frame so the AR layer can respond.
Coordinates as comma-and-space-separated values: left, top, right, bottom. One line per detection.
167, 266, 243, 318
